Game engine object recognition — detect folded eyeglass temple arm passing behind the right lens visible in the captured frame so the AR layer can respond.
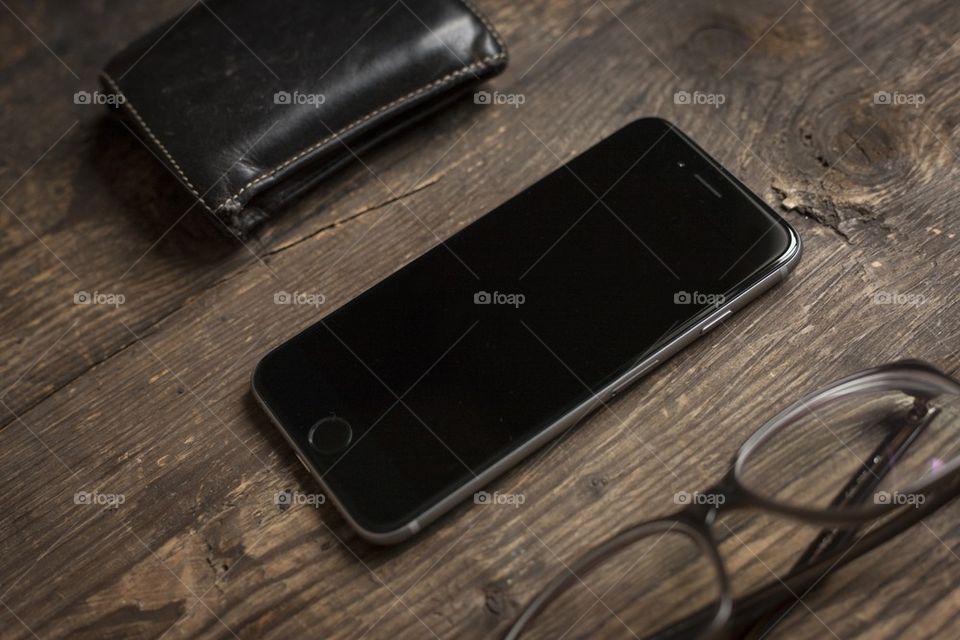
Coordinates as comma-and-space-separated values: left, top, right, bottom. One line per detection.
743, 398, 933, 640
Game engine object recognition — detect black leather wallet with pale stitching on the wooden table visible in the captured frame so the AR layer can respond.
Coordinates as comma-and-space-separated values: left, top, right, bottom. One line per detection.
102, 0, 507, 235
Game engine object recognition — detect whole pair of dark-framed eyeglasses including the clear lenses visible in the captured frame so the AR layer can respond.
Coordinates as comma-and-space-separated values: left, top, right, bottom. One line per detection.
506, 361, 960, 640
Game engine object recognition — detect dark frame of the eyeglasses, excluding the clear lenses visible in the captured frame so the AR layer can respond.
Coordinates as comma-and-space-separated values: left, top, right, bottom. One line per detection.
504, 360, 960, 640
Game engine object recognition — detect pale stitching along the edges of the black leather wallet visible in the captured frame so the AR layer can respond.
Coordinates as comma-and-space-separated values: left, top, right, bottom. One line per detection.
100, 0, 507, 220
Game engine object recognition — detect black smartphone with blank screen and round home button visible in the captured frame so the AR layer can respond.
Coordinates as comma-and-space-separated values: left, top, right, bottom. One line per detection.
252, 118, 801, 544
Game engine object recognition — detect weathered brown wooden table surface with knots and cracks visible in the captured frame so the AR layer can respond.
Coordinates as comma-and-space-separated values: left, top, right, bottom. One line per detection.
0, 0, 960, 640
